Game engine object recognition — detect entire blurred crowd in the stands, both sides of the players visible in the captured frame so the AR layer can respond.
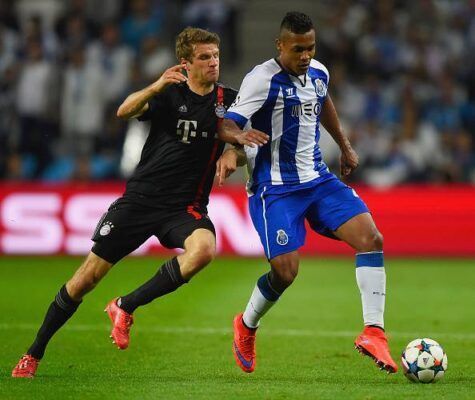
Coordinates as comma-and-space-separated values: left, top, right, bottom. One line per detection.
0, 0, 475, 186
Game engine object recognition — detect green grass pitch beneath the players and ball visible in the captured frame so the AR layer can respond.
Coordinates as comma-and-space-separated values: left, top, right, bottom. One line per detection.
0, 257, 475, 400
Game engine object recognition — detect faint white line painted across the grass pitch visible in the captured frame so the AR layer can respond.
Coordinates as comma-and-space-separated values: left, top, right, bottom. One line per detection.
0, 324, 475, 341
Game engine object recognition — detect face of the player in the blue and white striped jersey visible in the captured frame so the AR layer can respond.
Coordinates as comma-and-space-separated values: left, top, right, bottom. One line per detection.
276, 29, 315, 75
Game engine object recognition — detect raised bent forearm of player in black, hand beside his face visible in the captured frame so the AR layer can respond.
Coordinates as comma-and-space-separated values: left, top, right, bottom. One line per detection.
117, 65, 187, 119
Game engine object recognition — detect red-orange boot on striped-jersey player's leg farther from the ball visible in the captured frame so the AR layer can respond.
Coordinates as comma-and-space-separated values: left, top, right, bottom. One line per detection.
233, 313, 256, 373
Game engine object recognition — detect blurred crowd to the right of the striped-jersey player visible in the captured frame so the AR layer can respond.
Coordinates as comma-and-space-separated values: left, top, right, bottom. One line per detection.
317, 0, 475, 186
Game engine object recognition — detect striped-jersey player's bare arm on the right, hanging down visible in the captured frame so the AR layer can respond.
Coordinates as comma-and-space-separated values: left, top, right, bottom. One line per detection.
320, 95, 359, 177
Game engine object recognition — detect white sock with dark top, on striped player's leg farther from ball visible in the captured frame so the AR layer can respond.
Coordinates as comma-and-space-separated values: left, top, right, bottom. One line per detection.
242, 274, 280, 328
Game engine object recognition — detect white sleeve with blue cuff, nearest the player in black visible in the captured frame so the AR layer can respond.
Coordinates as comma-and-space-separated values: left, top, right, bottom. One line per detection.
224, 70, 269, 129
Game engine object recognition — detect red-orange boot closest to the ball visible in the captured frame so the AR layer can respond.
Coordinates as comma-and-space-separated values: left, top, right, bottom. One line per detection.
355, 326, 398, 374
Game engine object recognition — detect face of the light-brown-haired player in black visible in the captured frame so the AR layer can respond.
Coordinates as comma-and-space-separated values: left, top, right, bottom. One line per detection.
186, 43, 219, 84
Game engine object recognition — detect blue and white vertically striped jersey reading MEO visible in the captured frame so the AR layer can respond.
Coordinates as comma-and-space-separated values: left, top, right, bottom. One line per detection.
225, 59, 330, 192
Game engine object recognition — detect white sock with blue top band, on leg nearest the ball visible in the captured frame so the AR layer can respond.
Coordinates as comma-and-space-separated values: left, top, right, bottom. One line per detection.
356, 251, 386, 328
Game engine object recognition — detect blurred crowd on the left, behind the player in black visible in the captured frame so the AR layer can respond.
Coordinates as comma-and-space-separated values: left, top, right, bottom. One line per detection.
0, 0, 238, 181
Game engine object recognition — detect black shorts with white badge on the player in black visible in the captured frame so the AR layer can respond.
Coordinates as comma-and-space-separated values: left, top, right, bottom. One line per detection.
92, 197, 216, 264
